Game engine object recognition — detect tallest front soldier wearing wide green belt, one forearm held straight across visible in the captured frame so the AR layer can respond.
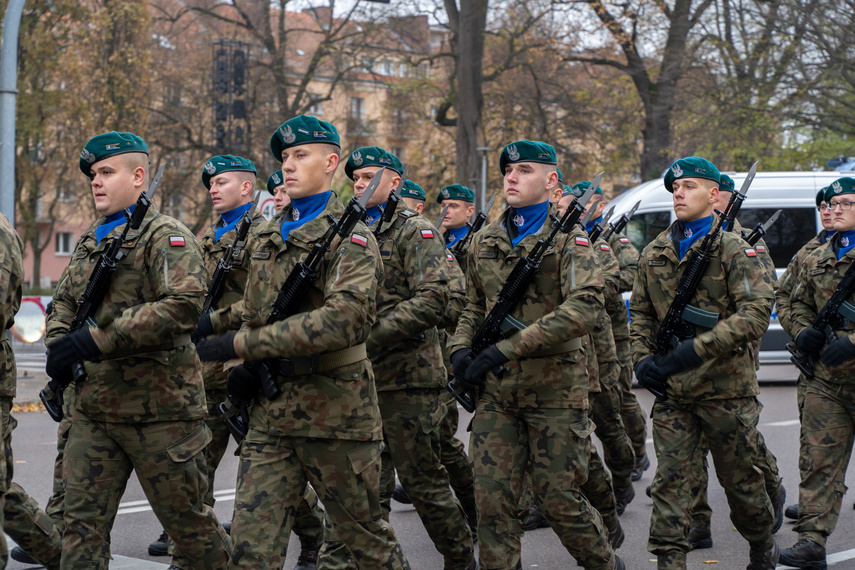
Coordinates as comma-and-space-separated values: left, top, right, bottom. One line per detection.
199, 115, 409, 570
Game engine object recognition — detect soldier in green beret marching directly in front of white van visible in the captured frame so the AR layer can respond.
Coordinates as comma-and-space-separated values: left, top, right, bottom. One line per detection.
629, 157, 778, 570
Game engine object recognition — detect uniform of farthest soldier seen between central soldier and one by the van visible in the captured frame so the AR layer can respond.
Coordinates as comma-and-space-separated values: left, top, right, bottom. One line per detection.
606, 233, 647, 457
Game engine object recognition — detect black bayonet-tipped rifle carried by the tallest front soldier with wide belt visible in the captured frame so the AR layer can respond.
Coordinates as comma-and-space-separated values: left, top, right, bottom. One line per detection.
219, 167, 385, 441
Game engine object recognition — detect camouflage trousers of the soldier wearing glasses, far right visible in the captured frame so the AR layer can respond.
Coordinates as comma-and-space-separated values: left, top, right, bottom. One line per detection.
793, 380, 855, 546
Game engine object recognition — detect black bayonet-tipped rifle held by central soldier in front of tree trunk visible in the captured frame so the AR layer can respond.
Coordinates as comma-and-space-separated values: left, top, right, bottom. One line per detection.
447, 172, 604, 412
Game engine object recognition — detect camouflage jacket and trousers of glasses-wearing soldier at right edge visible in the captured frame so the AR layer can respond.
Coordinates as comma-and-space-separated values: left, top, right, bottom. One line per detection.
789, 234, 855, 547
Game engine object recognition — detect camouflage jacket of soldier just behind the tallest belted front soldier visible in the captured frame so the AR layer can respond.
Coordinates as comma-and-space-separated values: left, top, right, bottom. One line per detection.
368, 207, 460, 391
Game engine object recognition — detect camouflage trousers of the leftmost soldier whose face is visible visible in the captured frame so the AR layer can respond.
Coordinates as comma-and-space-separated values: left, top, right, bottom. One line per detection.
62, 411, 229, 570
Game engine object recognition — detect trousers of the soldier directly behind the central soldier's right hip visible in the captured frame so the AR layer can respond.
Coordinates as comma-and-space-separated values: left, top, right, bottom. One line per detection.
591, 370, 635, 487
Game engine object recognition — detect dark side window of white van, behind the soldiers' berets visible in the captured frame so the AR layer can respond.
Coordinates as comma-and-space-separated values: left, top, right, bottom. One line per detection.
739, 207, 817, 268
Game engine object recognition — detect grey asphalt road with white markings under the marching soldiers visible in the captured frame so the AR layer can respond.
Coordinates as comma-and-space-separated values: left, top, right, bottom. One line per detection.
8, 366, 855, 570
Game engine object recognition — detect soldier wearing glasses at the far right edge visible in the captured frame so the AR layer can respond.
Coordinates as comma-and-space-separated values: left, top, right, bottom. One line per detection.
781, 177, 855, 569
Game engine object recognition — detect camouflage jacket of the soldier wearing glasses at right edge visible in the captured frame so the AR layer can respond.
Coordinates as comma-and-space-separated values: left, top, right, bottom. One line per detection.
790, 234, 855, 390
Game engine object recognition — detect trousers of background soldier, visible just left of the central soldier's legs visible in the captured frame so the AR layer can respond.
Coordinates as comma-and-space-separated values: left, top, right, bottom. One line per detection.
439, 389, 476, 521
